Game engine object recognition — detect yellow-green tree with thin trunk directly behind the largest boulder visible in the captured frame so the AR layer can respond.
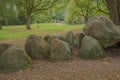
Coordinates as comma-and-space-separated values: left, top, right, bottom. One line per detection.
74, 0, 98, 22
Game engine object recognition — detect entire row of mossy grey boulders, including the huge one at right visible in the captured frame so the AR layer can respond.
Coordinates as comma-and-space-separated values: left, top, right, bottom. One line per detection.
0, 16, 120, 72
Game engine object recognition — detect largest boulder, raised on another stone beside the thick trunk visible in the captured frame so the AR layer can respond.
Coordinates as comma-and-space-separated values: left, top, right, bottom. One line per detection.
83, 16, 120, 48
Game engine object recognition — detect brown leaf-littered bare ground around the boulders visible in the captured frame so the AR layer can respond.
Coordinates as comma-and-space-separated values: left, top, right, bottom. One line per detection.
0, 31, 120, 80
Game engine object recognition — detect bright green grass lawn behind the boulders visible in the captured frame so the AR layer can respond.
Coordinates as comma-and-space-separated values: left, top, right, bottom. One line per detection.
0, 23, 84, 40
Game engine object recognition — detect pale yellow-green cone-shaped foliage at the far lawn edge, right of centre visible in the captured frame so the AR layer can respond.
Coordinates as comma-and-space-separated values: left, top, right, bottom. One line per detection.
65, 0, 83, 24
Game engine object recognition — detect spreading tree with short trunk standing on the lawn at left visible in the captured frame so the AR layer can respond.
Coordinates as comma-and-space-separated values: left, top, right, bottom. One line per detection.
17, 0, 58, 29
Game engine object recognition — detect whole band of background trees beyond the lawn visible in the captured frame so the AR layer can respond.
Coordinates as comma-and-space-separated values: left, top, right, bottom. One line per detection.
0, 0, 120, 29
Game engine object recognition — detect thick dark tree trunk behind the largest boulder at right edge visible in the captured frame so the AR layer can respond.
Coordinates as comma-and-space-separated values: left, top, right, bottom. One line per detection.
106, 0, 120, 26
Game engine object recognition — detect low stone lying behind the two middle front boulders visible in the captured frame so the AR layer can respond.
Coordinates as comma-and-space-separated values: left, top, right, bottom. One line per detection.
44, 34, 66, 43
